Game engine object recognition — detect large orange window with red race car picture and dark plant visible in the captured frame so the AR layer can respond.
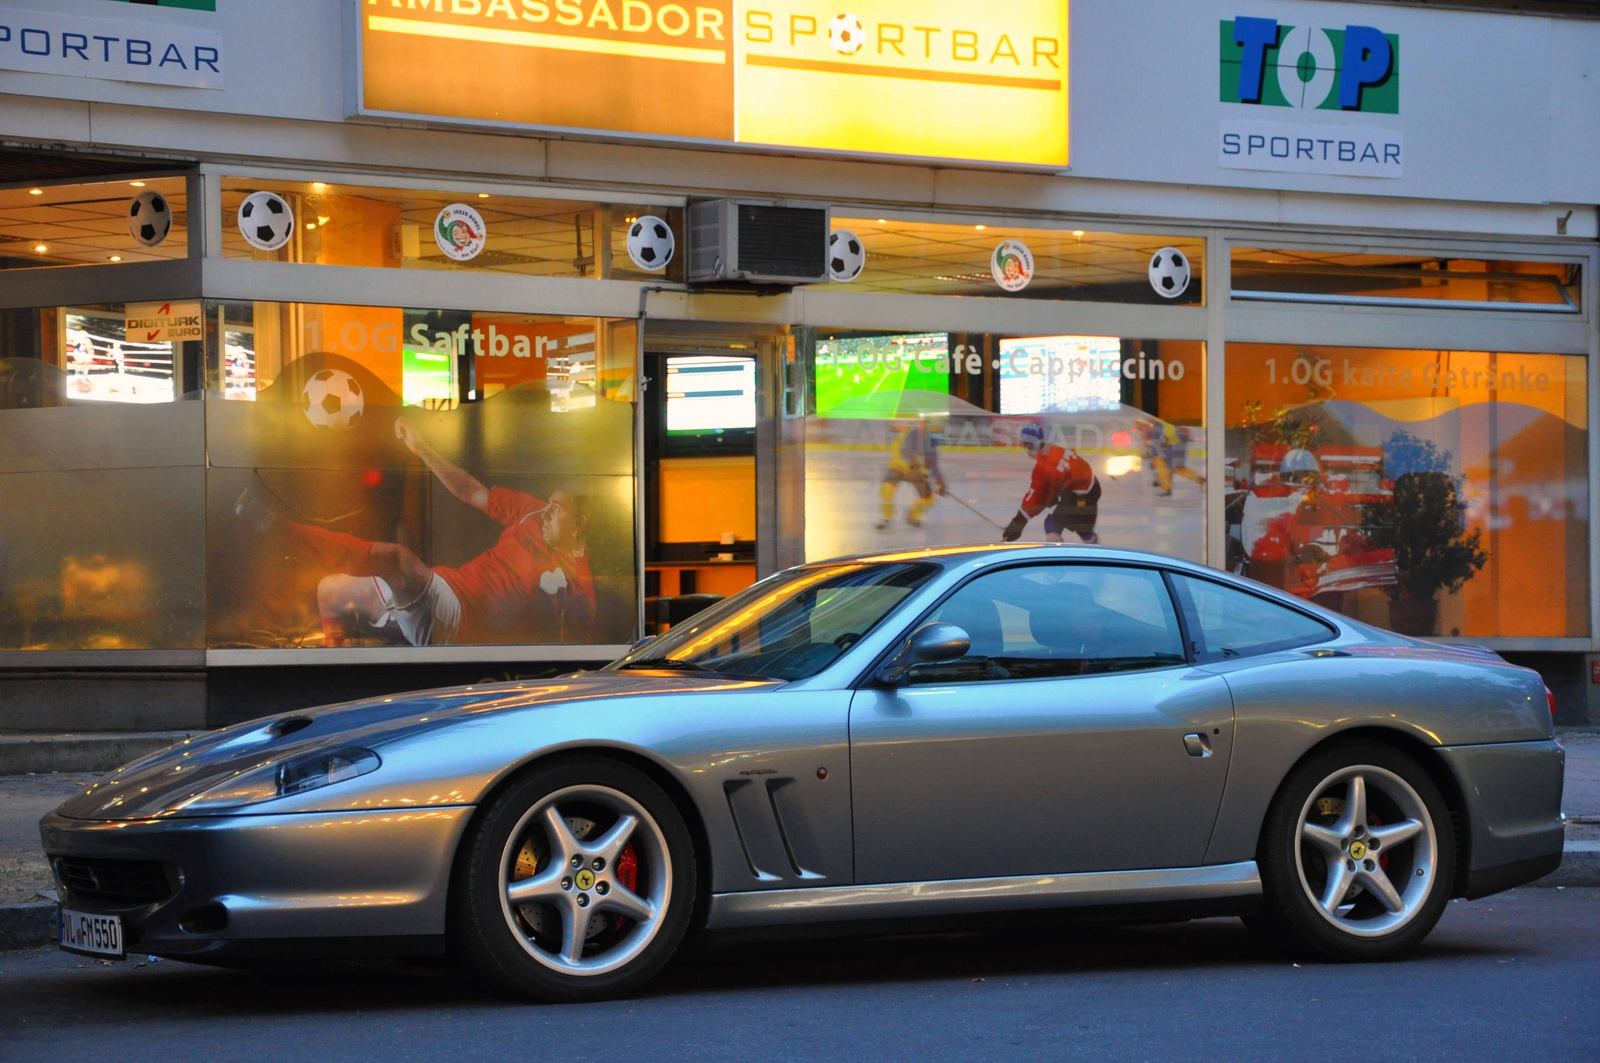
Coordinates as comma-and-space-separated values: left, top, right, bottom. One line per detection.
1227, 344, 1590, 637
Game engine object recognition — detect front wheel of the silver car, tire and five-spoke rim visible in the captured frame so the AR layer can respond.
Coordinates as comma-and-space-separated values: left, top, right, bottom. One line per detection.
451, 757, 696, 1001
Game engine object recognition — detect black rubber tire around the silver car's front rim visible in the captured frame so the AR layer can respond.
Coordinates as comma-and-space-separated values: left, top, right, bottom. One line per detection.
450, 756, 698, 1002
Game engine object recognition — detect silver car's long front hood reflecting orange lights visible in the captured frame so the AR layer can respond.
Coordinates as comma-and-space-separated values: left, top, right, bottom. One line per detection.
56, 672, 779, 820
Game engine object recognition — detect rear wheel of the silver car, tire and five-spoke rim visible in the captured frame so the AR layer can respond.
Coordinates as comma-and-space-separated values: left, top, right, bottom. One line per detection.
1253, 741, 1456, 961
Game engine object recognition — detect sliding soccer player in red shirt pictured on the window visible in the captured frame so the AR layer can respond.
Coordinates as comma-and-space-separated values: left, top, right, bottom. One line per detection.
235, 418, 595, 645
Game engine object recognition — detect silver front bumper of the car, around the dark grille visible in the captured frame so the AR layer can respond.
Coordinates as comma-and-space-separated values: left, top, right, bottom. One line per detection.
38, 805, 474, 959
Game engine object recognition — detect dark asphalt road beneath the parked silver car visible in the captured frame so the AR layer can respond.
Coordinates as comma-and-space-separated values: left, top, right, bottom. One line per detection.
0, 889, 1600, 1063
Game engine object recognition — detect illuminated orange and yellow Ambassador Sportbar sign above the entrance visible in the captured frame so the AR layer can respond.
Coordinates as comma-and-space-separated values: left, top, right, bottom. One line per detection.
357, 0, 1069, 168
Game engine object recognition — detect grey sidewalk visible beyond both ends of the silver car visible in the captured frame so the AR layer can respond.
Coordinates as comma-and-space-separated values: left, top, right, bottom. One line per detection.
0, 730, 1600, 949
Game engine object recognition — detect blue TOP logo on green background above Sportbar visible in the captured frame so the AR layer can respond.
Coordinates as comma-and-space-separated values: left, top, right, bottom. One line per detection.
1219, 14, 1400, 114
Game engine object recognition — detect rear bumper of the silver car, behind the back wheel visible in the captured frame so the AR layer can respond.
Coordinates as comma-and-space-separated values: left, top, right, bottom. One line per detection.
1438, 740, 1566, 898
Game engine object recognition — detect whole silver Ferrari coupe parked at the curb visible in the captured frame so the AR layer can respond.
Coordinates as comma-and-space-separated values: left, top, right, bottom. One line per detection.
42, 546, 1563, 1001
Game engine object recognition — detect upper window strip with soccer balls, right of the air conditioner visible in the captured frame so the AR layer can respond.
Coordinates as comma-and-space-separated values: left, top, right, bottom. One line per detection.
812, 216, 1205, 306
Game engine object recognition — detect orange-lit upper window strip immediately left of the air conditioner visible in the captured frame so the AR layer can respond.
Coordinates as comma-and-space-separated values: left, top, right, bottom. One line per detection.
222, 178, 683, 280
